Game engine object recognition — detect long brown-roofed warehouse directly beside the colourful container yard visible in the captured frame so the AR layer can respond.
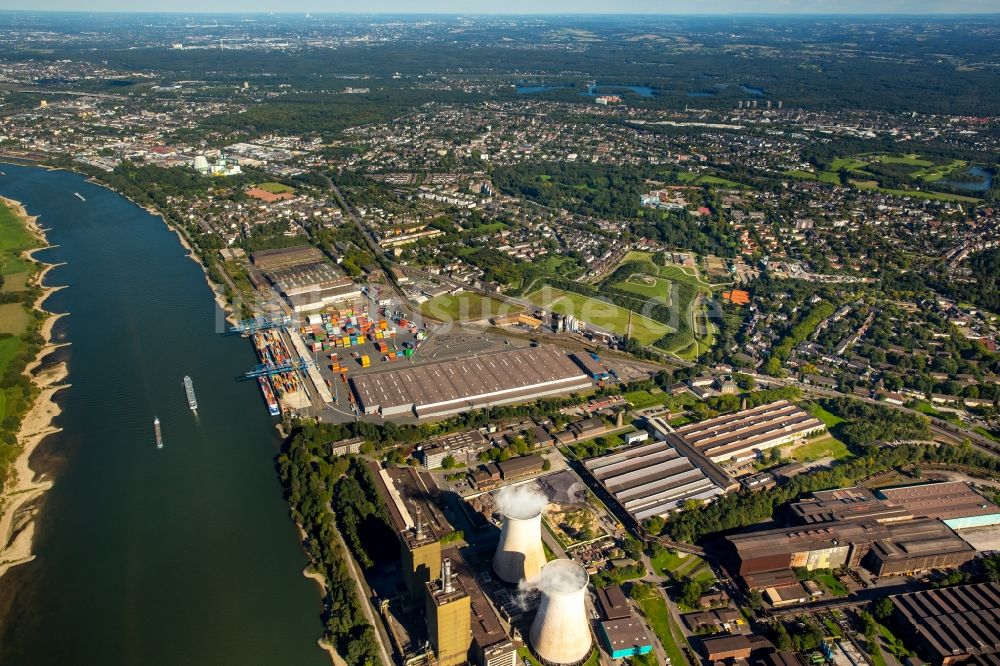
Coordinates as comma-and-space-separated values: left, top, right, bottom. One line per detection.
350, 346, 593, 418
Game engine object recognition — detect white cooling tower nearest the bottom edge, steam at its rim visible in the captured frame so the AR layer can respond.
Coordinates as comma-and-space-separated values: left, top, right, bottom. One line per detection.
528, 560, 591, 664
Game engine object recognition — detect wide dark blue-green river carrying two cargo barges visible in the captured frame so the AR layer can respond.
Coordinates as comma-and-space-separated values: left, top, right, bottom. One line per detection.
0, 165, 330, 666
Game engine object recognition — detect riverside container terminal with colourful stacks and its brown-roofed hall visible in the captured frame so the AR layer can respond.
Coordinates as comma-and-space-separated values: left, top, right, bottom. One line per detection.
231, 274, 650, 422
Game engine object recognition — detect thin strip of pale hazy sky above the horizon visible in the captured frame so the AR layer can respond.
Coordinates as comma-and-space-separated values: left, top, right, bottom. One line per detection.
0, 0, 1000, 14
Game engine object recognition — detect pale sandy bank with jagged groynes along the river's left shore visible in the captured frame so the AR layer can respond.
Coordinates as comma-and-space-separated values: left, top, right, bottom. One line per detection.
0, 197, 68, 576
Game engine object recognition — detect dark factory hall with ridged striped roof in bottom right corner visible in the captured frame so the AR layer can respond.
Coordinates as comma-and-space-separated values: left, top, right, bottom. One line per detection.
889, 583, 1000, 666
